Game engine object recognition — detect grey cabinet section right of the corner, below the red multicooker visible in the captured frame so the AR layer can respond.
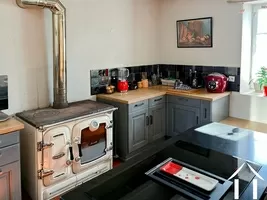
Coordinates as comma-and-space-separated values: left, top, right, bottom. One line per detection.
167, 95, 229, 136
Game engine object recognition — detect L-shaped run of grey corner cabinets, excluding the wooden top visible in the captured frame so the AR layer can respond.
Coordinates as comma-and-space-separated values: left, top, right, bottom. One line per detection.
97, 95, 229, 160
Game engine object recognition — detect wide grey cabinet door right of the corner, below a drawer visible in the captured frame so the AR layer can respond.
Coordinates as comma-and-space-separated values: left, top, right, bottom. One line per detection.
168, 103, 200, 136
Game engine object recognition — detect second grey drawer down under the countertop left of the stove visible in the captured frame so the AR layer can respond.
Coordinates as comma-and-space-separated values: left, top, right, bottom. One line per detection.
0, 144, 20, 166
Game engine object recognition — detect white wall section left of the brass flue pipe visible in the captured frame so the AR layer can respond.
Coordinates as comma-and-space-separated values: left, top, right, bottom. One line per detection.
0, 0, 48, 114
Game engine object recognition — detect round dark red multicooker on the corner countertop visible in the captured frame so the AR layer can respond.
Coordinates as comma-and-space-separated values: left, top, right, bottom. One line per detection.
205, 72, 227, 93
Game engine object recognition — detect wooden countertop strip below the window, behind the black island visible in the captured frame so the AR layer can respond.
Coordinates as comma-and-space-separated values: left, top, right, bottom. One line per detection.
220, 117, 267, 133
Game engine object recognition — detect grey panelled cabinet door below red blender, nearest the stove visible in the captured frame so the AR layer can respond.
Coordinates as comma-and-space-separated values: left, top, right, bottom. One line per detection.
128, 109, 149, 153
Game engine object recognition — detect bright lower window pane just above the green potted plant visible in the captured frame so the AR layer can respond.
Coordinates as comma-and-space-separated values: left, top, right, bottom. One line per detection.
252, 34, 267, 76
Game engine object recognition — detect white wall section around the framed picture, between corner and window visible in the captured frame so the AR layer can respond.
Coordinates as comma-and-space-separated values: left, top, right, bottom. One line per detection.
160, 0, 242, 67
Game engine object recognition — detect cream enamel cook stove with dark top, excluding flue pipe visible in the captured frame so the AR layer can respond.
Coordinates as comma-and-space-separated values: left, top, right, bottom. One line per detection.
17, 101, 116, 200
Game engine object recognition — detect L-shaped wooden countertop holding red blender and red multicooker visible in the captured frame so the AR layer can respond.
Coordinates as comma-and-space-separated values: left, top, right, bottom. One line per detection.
97, 86, 230, 104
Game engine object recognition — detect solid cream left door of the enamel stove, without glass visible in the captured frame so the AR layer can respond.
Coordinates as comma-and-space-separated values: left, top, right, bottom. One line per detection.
41, 126, 71, 186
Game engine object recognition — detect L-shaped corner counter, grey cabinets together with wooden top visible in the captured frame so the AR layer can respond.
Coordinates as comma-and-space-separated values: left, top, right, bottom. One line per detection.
97, 86, 230, 160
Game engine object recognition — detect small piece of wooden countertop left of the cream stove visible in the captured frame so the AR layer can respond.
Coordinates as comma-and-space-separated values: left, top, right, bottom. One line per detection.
0, 118, 24, 135
